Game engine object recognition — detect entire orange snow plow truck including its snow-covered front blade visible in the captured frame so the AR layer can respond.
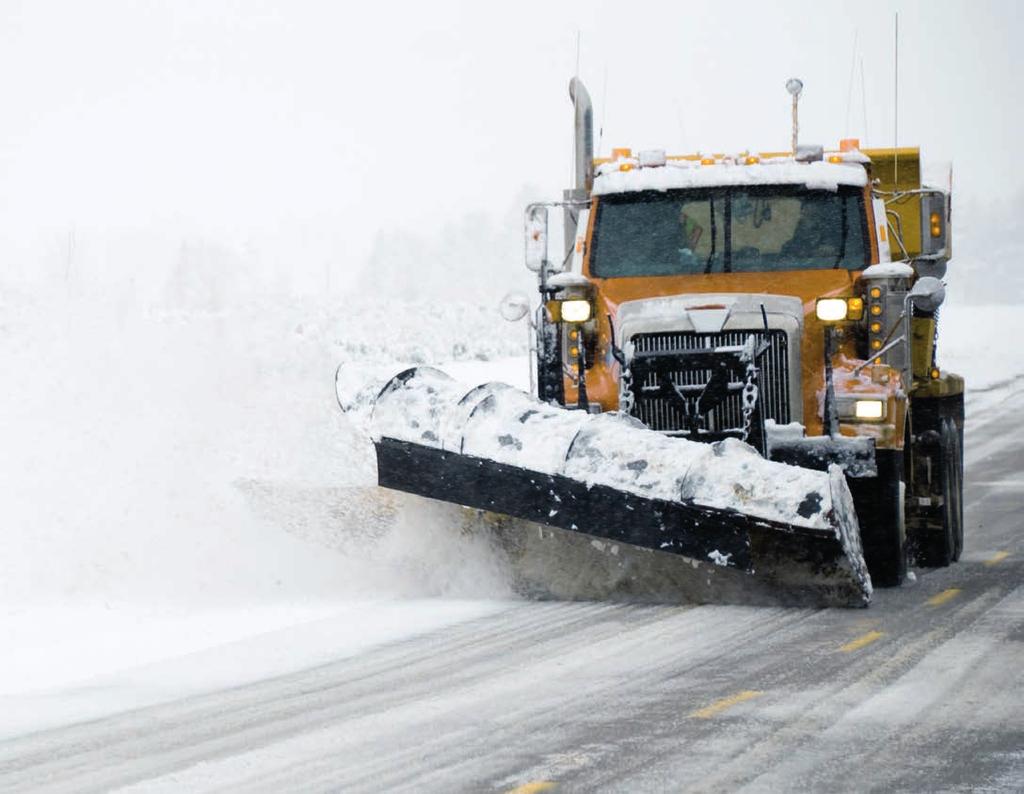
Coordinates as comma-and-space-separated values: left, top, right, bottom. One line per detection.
339, 79, 964, 605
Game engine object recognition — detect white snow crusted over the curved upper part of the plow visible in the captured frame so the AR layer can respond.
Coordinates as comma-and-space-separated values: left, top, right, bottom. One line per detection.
370, 368, 834, 530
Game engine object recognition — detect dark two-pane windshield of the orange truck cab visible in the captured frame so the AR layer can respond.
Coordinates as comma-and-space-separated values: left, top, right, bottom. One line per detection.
590, 185, 869, 279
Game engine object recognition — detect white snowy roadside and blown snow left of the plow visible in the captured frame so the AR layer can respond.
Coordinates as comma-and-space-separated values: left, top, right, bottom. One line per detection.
0, 283, 527, 712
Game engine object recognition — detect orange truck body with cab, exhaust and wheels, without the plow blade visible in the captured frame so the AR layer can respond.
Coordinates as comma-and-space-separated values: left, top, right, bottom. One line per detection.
516, 80, 964, 585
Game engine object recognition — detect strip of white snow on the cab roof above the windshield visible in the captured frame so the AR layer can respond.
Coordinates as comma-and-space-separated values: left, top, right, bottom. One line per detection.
594, 158, 867, 196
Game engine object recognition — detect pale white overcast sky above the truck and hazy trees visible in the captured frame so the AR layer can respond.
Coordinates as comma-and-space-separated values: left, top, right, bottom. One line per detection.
0, 0, 1024, 270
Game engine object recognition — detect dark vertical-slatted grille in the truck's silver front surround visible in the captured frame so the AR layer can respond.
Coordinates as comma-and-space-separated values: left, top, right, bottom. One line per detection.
633, 330, 790, 432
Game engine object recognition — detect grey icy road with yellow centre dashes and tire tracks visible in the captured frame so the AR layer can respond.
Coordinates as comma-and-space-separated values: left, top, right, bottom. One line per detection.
0, 392, 1024, 792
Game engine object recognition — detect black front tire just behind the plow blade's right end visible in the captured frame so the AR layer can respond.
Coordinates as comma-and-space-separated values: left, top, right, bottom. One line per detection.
848, 450, 907, 587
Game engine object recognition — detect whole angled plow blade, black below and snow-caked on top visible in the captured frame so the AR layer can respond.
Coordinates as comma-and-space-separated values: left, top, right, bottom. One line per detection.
339, 367, 871, 607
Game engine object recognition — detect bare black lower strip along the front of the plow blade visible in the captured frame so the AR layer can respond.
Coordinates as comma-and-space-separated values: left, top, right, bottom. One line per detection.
375, 437, 869, 607
